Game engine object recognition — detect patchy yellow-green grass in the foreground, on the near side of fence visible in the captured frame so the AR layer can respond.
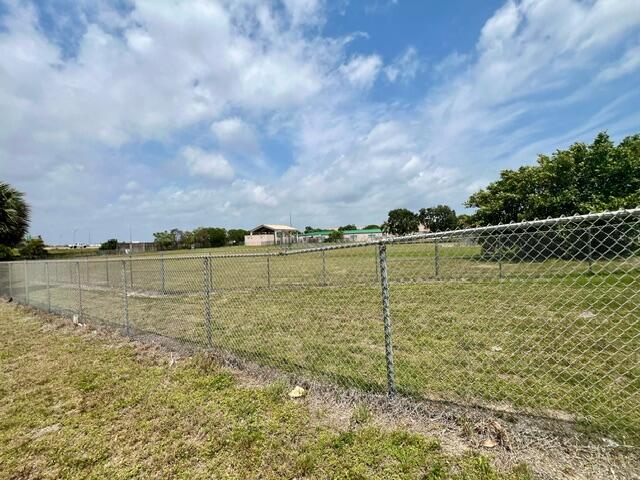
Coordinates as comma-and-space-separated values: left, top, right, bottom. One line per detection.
0, 303, 532, 480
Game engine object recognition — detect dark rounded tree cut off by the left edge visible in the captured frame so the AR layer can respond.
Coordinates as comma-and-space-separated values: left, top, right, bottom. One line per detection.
0, 182, 31, 247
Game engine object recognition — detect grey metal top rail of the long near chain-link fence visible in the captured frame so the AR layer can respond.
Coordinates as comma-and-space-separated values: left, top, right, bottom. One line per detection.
4, 207, 640, 265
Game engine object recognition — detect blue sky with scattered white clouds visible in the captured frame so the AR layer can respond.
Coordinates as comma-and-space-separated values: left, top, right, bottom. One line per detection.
0, 0, 640, 244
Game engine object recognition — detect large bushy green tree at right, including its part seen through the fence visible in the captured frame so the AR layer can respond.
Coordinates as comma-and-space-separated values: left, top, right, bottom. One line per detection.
467, 132, 640, 260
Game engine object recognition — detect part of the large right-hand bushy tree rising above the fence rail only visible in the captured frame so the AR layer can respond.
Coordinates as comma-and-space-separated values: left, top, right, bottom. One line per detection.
466, 132, 640, 225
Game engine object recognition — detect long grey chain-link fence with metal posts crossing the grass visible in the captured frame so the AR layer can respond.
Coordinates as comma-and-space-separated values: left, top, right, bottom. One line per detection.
0, 209, 640, 445
